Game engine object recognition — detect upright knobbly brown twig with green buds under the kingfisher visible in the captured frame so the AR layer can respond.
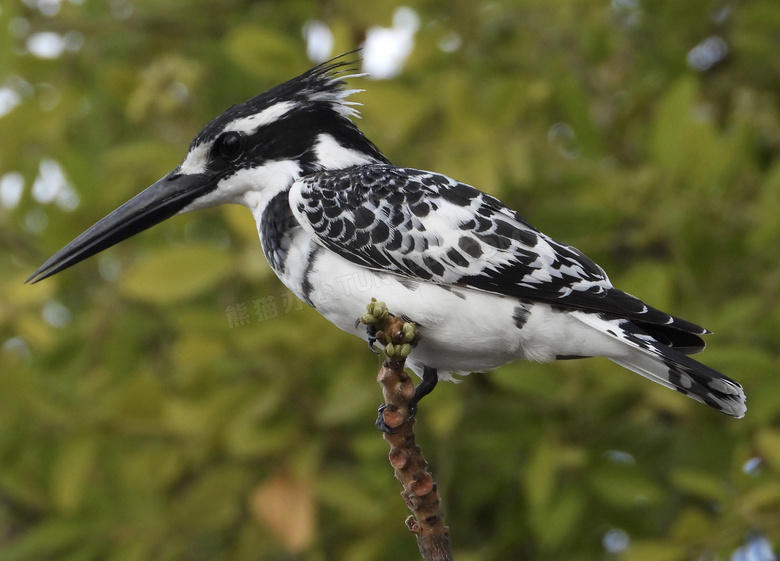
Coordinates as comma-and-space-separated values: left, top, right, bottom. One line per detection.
363, 301, 452, 561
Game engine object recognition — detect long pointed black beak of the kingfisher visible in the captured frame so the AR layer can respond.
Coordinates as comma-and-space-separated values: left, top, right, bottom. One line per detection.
26, 170, 218, 283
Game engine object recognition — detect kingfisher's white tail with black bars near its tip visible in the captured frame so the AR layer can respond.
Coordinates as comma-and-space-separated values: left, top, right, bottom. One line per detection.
577, 313, 747, 419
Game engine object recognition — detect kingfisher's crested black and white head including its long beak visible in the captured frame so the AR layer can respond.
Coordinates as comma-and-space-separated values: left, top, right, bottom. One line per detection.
27, 55, 387, 282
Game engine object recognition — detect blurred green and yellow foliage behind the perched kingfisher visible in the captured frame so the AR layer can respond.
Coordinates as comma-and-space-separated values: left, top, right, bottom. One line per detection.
0, 0, 780, 561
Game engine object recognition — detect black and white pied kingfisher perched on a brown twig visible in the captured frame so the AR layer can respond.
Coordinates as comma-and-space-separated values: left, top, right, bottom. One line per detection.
28, 55, 746, 417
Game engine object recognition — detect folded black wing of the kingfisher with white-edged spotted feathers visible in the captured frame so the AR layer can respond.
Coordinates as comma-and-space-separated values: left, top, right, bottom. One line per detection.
290, 165, 706, 334
